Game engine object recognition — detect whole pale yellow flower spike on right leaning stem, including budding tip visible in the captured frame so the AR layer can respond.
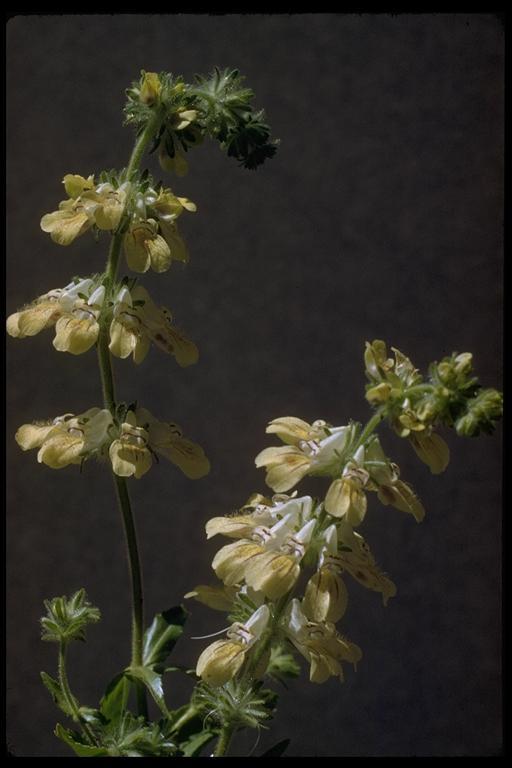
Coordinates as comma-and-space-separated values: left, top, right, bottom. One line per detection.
187, 341, 501, 686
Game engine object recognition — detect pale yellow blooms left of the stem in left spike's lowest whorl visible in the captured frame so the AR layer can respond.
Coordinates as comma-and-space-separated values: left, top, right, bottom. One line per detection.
16, 408, 112, 469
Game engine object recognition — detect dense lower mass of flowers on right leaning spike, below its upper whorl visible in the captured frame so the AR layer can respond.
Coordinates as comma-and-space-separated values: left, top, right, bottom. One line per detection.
192, 494, 388, 685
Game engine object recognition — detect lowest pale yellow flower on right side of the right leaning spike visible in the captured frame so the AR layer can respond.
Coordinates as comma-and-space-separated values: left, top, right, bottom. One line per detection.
283, 598, 363, 683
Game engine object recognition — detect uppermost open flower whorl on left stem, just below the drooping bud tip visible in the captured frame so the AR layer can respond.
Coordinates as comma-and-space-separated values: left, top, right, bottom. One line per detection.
41, 174, 196, 272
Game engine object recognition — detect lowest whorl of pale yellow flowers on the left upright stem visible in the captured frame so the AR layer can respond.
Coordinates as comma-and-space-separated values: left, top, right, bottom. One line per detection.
16, 408, 210, 479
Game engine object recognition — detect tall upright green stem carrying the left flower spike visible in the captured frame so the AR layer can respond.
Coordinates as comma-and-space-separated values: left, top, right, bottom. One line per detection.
98, 105, 162, 718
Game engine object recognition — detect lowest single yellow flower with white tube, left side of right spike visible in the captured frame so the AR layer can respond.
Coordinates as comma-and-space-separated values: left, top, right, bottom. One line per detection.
196, 605, 270, 686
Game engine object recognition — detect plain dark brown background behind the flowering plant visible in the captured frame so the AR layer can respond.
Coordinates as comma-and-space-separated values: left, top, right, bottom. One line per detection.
7, 14, 503, 756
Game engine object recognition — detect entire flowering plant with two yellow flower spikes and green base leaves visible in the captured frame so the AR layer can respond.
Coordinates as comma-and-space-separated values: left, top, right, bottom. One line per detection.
7, 69, 502, 757
